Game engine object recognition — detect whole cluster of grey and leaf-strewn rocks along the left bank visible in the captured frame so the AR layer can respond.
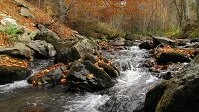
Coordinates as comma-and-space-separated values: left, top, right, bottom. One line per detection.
0, 13, 119, 92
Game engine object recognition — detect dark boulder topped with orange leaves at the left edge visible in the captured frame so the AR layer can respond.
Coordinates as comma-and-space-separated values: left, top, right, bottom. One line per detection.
0, 55, 31, 84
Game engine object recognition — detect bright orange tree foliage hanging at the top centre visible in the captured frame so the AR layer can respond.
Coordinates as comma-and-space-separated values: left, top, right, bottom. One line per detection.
67, 0, 145, 20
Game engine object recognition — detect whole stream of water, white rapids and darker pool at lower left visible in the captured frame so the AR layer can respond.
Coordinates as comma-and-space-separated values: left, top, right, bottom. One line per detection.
0, 46, 160, 112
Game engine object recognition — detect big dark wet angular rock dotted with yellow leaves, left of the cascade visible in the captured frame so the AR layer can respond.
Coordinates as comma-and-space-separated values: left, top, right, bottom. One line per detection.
68, 61, 114, 92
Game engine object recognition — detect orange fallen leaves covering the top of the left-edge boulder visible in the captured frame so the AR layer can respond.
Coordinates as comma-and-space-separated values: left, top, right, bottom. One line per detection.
0, 55, 29, 68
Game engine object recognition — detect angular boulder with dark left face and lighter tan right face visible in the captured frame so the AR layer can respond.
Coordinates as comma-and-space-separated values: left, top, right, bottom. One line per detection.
55, 39, 96, 63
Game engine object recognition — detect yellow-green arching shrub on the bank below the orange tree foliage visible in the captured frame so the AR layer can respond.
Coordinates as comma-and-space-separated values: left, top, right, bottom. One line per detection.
69, 19, 124, 39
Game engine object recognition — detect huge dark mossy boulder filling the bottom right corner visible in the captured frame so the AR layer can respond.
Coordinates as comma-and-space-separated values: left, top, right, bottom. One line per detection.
145, 56, 199, 112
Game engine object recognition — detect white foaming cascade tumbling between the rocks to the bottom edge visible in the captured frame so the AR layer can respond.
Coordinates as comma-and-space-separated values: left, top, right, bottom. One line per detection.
61, 46, 159, 112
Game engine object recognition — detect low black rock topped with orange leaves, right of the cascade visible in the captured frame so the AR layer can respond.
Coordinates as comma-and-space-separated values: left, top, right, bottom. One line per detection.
156, 52, 191, 64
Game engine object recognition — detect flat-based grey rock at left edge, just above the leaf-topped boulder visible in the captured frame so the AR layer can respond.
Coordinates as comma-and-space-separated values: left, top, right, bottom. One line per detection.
0, 43, 35, 58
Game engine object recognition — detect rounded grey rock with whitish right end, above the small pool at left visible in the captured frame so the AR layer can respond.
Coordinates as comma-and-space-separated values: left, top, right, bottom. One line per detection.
28, 40, 56, 58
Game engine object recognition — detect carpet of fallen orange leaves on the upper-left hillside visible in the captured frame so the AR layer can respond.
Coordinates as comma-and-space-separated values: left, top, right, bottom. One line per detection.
0, 0, 72, 39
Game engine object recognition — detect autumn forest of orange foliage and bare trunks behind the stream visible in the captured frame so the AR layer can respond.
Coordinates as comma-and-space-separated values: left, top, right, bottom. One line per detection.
27, 0, 199, 36
